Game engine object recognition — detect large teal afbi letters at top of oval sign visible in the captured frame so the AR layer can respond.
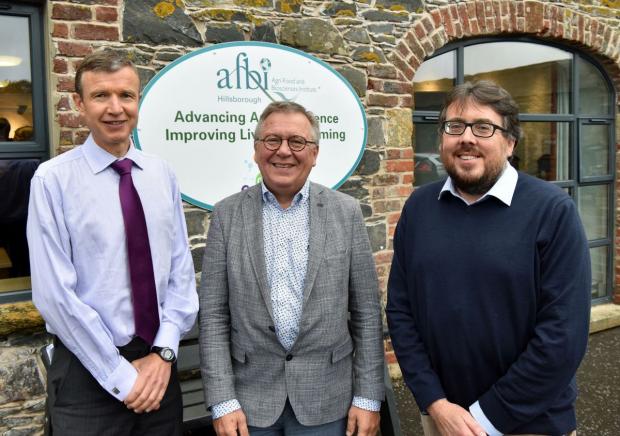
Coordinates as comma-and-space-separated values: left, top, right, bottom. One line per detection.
216, 52, 271, 90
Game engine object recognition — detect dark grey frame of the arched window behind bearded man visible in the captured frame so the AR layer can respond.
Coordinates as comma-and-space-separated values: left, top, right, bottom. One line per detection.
412, 37, 617, 304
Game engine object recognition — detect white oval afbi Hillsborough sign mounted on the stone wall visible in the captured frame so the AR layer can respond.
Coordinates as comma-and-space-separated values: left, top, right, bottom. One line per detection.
134, 42, 366, 209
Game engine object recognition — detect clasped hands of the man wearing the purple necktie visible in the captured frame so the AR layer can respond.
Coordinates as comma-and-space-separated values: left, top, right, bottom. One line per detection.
125, 353, 172, 413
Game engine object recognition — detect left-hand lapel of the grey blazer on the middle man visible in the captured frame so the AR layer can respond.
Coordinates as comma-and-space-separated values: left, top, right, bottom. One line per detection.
241, 184, 273, 320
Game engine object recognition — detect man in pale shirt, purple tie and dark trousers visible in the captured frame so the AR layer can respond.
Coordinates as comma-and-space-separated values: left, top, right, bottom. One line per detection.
28, 52, 198, 436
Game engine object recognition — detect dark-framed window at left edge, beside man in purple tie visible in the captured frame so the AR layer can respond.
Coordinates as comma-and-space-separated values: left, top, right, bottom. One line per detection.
0, 2, 48, 302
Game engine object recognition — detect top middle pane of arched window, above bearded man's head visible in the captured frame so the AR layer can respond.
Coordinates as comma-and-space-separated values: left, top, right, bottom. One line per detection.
464, 42, 572, 114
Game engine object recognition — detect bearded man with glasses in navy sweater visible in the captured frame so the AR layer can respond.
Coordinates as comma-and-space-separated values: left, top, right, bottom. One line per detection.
386, 81, 591, 436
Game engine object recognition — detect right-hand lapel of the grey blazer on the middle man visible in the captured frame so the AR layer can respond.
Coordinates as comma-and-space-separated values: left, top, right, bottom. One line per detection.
304, 183, 328, 307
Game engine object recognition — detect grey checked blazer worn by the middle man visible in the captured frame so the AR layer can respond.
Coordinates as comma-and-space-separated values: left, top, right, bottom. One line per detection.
199, 183, 384, 427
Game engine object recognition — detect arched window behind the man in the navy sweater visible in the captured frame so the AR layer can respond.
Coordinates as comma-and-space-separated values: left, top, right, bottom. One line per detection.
413, 39, 615, 299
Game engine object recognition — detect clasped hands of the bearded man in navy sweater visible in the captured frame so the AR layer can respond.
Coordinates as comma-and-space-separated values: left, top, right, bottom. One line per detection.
428, 398, 487, 436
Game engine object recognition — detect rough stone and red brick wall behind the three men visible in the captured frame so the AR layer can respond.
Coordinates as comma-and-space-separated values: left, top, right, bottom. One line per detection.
0, 0, 620, 435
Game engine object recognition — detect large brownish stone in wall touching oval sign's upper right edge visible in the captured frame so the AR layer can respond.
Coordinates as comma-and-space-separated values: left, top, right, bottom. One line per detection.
280, 18, 348, 55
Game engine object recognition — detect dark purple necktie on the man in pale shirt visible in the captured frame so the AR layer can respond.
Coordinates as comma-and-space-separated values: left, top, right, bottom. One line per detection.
111, 159, 159, 345
